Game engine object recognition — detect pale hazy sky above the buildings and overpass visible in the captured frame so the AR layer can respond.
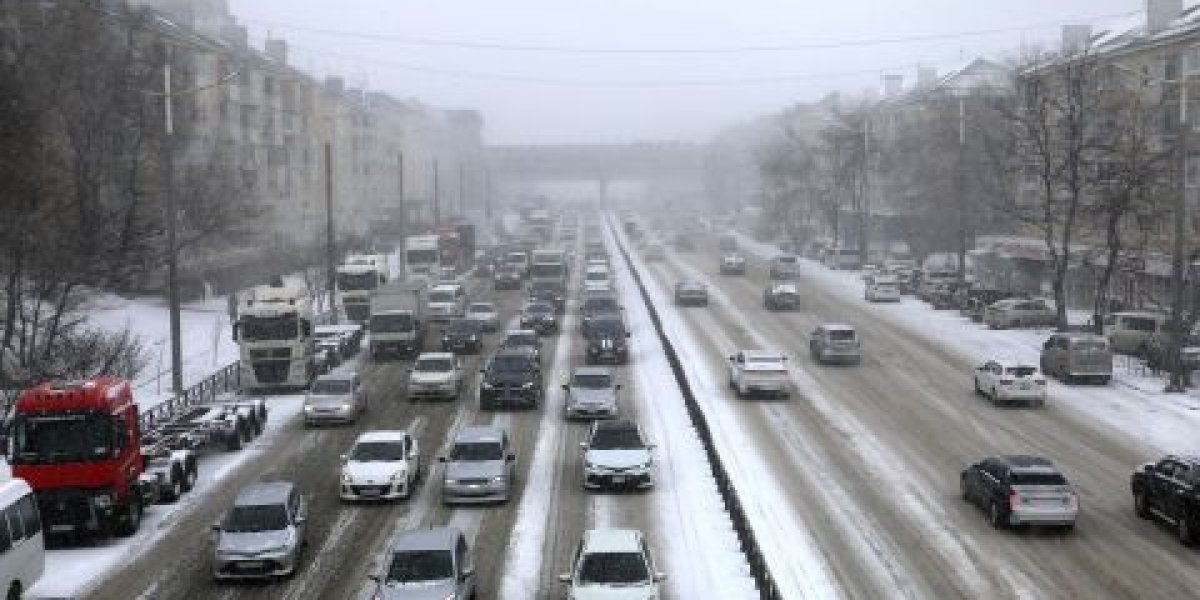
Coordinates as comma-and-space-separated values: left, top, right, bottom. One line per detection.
230, 0, 1142, 143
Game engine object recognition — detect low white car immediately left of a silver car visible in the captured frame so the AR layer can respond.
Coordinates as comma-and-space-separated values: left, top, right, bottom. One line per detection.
340, 430, 421, 502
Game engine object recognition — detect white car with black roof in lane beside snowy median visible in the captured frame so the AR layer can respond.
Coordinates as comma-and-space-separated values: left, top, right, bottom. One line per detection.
580, 420, 654, 490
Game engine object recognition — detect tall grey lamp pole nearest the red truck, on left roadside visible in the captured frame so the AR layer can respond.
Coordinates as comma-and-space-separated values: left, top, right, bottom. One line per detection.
162, 46, 184, 396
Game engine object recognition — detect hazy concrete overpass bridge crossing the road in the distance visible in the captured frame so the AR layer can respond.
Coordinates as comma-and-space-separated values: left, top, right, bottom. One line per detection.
485, 142, 704, 198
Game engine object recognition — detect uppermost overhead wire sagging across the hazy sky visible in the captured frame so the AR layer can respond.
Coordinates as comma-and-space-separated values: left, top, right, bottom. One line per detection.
244, 11, 1138, 54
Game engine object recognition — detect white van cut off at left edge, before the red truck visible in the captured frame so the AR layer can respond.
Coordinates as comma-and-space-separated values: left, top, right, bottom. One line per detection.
0, 475, 46, 598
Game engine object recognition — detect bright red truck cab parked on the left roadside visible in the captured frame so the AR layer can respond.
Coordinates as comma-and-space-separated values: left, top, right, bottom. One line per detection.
10, 377, 144, 538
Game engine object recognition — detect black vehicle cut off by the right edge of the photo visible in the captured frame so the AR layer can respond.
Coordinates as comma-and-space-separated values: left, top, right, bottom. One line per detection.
1129, 456, 1200, 545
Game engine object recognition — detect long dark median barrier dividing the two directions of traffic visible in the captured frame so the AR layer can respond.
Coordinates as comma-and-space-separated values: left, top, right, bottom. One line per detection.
608, 222, 784, 600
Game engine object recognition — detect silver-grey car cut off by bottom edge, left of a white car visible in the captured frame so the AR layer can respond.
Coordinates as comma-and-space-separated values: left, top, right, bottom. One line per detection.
371, 527, 476, 600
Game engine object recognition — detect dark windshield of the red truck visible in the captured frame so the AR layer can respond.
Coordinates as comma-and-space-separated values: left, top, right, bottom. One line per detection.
10, 412, 118, 464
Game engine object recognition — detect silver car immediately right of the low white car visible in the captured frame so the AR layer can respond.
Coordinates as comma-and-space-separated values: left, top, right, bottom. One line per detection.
438, 425, 516, 504
